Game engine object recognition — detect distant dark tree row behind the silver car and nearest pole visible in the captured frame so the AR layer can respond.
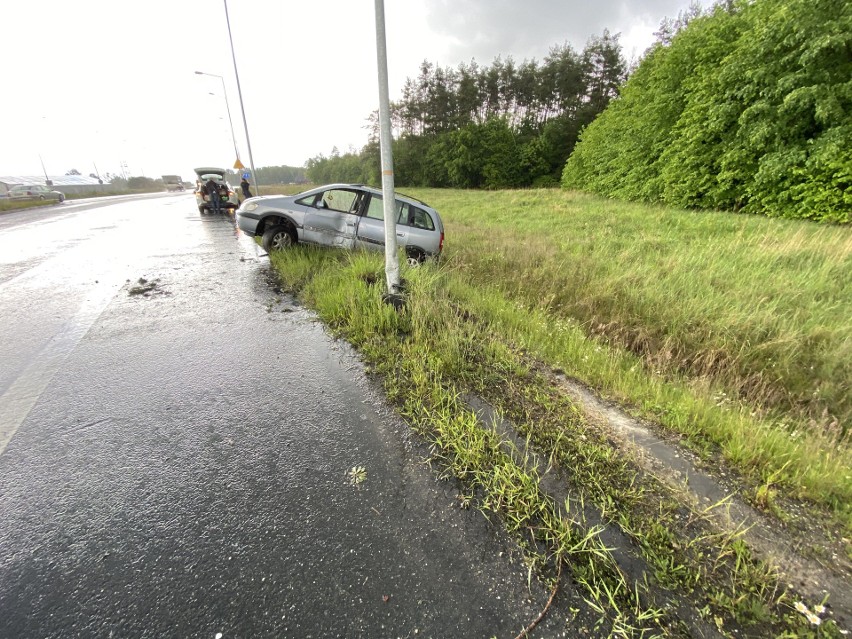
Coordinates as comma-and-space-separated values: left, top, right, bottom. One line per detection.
306, 31, 627, 188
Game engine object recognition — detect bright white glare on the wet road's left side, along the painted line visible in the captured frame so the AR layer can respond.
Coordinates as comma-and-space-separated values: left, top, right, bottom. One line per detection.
0, 198, 201, 453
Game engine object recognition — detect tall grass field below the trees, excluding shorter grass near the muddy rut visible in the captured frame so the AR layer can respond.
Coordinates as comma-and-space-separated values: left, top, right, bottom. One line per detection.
415, 189, 852, 438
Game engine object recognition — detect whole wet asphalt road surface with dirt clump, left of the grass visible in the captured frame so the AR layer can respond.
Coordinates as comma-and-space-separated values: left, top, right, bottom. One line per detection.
0, 195, 573, 639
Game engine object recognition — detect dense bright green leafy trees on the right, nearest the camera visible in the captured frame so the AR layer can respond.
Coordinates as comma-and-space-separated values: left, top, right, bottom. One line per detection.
562, 0, 852, 223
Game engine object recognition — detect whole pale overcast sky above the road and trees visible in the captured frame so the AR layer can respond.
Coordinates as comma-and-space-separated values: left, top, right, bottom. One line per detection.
0, 0, 689, 179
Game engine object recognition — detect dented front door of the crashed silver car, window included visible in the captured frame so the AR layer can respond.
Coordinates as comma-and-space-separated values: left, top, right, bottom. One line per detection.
302, 188, 362, 249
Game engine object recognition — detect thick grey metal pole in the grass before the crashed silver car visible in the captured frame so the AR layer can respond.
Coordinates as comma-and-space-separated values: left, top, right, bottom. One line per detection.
376, 0, 400, 301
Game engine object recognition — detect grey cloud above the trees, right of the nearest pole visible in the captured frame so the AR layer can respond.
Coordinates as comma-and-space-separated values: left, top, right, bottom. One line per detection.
426, 0, 689, 66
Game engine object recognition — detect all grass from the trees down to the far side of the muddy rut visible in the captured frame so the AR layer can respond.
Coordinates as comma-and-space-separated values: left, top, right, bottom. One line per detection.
413, 190, 852, 530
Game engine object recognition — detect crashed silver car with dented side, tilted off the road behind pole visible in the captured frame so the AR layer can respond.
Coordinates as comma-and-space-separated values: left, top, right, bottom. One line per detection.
237, 184, 444, 263
